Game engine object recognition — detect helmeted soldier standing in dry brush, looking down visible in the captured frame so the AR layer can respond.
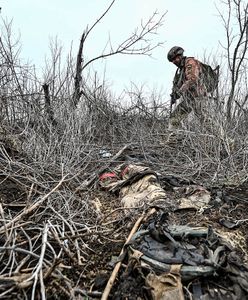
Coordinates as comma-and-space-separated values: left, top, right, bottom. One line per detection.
167, 46, 215, 129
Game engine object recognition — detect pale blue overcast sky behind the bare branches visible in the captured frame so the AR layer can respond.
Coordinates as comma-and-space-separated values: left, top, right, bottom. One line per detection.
0, 0, 224, 98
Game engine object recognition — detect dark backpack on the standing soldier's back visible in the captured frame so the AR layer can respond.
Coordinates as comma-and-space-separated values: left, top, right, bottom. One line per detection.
201, 62, 220, 93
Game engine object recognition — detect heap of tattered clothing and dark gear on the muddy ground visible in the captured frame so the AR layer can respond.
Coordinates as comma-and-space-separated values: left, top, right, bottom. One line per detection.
100, 164, 248, 300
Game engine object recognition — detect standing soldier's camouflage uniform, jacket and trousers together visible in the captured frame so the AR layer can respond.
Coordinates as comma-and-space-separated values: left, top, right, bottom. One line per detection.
170, 57, 207, 127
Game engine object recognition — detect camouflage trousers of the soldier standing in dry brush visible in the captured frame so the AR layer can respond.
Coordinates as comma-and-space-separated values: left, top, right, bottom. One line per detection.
169, 97, 210, 128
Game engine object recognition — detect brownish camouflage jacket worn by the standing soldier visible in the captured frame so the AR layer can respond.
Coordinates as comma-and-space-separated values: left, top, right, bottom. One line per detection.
173, 57, 207, 97
